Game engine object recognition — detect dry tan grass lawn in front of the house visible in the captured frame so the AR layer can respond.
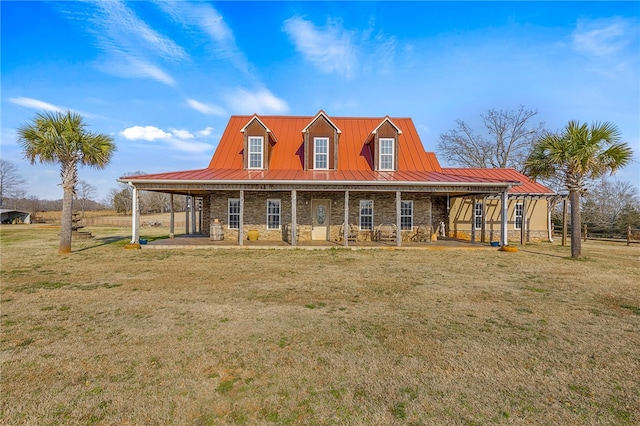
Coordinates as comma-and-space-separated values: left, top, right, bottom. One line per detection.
0, 225, 640, 425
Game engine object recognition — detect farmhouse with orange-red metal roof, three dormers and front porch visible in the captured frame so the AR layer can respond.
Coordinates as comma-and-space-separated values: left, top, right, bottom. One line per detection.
119, 111, 553, 246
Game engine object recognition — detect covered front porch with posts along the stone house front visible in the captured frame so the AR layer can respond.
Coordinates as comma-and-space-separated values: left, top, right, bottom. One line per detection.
125, 181, 514, 247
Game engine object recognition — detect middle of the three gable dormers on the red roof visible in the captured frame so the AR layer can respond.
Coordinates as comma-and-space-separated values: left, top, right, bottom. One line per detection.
302, 110, 342, 170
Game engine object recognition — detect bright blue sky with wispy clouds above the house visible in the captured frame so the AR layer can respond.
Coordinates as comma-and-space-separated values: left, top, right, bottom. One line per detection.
0, 1, 640, 200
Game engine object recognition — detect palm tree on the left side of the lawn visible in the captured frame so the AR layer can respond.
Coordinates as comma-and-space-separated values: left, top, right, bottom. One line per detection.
18, 111, 116, 254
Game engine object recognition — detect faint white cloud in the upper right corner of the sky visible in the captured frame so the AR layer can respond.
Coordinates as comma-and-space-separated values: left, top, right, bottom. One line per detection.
571, 18, 637, 56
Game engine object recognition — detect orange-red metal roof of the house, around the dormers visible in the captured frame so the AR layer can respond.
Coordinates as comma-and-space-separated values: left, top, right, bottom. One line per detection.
123, 111, 553, 194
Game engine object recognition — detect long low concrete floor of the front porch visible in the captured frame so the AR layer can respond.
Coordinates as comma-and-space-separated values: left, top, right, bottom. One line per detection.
142, 235, 498, 250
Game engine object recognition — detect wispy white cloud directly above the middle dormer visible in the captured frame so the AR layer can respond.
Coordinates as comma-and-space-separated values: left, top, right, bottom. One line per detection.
284, 17, 358, 79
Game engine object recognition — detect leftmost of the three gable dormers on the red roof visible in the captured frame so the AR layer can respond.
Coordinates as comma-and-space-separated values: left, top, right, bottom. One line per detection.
240, 114, 278, 170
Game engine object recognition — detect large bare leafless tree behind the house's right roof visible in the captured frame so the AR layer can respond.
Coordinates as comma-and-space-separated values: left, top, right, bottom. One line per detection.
438, 105, 544, 171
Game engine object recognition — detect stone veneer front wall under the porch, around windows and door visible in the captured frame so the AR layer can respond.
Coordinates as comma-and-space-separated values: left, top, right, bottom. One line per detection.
203, 191, 446, 241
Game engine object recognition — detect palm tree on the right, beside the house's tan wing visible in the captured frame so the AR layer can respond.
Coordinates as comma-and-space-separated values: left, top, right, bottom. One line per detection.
525, 120, 633, 257
